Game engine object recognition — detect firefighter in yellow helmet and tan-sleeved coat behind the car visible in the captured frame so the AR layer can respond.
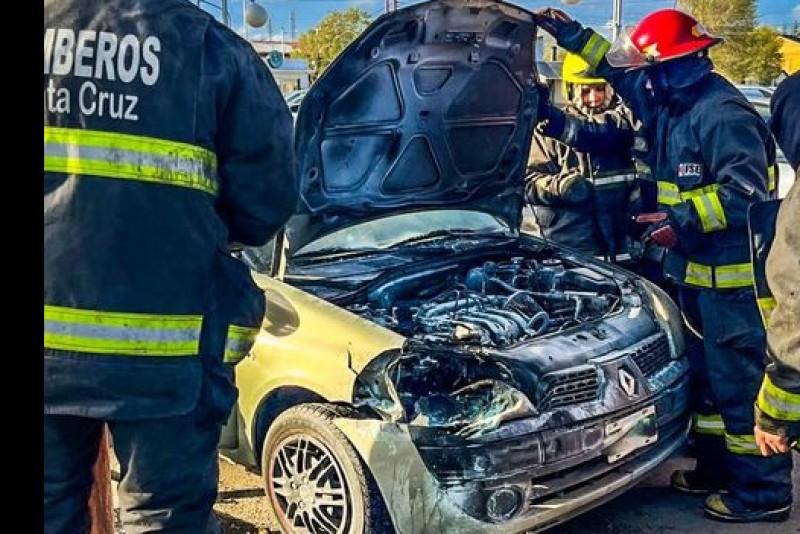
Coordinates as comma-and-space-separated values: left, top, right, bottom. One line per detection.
525, 54, 636, 263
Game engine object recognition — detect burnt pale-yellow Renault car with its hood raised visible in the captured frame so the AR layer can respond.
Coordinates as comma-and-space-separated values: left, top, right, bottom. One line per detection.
221, 0, 689, 534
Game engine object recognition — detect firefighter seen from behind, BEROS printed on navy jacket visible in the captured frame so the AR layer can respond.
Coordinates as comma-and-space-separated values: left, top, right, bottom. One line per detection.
44, 0, 297, 534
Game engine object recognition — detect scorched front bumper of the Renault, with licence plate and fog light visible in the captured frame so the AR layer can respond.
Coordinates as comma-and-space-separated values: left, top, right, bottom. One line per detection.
334, 377, 689, 534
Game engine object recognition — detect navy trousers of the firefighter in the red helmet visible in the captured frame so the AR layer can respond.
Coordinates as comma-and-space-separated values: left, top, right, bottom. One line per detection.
678, 286, 792, 509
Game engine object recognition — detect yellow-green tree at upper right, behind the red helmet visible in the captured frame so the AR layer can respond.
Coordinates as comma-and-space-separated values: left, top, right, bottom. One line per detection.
678, 0, 782, 83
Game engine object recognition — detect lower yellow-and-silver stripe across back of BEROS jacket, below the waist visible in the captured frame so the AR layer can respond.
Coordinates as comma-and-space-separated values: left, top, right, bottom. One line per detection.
44, 305, 203, 356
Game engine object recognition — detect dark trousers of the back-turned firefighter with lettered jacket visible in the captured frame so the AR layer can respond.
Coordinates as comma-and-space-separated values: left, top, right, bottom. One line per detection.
44, 410, 222, 534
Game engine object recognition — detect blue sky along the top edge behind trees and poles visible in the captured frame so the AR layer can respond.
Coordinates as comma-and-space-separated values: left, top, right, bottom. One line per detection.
205, 0, 800, 40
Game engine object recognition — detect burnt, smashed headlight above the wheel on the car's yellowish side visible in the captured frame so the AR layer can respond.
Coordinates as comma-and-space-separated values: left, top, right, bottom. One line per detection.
353, 350, 537, 436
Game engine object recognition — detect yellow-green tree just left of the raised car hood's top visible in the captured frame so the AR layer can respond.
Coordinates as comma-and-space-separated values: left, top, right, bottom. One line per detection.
294, 7, 371, 79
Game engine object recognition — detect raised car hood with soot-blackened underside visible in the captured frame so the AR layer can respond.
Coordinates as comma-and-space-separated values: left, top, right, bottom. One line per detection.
293, 0, 538, 250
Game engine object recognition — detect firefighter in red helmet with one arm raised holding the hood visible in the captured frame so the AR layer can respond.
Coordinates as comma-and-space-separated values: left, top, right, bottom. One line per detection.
537, 5, 792, 522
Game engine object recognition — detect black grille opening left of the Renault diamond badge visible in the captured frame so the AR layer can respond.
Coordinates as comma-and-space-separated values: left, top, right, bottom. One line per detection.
536, 365, 600, 411
